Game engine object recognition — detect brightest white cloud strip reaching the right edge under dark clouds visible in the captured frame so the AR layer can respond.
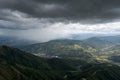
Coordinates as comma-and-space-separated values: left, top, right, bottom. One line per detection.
46, 22, 120, 34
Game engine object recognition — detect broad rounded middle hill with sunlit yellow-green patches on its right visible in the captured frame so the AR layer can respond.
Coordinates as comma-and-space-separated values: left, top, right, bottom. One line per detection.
22, 40, 96, 58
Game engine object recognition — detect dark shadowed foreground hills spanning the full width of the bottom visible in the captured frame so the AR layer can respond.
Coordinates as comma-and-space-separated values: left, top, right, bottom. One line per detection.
0, 46, 120, 80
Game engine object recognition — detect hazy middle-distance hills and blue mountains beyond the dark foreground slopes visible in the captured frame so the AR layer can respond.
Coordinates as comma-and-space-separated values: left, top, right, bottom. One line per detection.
20, 36, 120, 60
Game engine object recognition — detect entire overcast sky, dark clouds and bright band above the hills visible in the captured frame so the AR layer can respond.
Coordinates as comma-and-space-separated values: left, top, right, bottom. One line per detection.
0, 0, 120, 42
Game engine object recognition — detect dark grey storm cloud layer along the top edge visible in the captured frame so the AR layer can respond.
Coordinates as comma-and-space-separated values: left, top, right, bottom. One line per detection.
0, 0, 120, 20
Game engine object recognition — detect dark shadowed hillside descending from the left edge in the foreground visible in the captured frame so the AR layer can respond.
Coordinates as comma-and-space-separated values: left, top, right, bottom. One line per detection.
0, 46, 90, 80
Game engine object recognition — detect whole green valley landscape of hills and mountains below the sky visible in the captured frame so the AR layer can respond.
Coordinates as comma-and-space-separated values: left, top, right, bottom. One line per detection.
0, 37, 120, 80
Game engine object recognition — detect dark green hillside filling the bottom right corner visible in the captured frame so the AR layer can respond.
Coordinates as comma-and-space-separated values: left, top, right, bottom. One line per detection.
67, 63, 120, 80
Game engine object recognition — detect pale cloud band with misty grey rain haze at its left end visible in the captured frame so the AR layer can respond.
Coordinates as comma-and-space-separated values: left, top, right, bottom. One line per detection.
0, 17, 120, 42
